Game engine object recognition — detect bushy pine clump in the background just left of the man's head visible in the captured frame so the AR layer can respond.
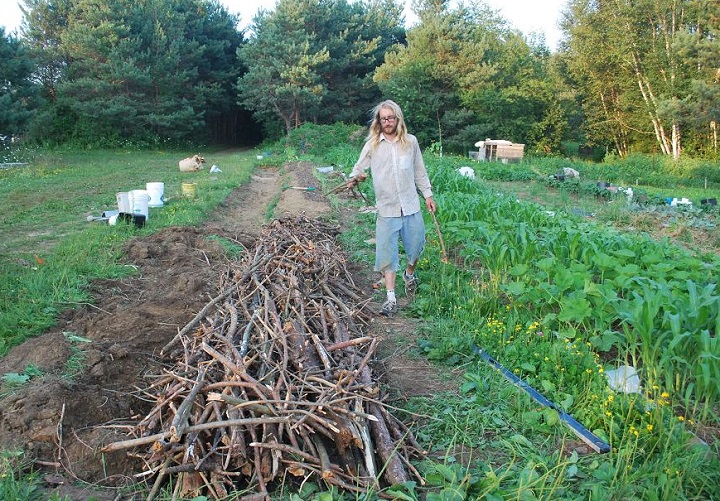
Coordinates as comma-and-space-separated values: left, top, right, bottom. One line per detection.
238, 0, 405, 133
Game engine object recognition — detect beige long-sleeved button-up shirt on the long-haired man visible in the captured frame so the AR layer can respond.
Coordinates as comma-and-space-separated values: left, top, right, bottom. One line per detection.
350, 134, 432, 217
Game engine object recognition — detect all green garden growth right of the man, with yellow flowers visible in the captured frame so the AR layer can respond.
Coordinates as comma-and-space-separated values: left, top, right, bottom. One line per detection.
306, 135, 720, 499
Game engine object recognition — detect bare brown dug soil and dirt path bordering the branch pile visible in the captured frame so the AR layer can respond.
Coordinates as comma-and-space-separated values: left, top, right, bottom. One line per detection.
0, 162, 456, 500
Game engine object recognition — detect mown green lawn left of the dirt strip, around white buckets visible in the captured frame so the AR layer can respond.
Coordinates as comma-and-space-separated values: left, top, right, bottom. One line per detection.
0, 146, 257, 355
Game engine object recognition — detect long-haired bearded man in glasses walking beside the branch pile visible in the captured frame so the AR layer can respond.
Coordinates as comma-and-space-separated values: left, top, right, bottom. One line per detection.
347, 100, 437, 316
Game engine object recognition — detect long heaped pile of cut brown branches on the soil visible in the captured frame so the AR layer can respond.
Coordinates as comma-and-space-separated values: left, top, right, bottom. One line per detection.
103, 216, 422, 499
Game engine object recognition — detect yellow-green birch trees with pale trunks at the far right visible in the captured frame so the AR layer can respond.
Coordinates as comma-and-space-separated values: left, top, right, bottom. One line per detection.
564, 0, 718, 159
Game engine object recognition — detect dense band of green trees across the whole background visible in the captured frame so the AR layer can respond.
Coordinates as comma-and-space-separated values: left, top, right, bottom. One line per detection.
0, 0, 720, 158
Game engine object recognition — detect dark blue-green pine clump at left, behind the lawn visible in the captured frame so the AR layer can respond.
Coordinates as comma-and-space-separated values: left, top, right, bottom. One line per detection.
16, 0, 248, 145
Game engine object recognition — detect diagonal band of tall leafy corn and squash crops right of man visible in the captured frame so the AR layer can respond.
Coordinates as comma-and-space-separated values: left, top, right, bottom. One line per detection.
422, 162, 720, 420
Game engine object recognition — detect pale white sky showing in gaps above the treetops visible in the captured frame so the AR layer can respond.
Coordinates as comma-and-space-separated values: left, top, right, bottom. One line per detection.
0, 0, 567, 50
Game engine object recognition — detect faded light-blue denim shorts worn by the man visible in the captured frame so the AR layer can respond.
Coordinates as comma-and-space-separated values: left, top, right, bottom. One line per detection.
375, 211, 425, 272
